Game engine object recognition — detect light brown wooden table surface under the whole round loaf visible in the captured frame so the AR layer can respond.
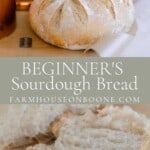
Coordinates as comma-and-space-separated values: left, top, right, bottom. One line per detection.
0, 11, 96, 57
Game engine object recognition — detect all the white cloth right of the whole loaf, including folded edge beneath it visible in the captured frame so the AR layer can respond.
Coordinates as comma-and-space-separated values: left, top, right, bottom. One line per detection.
92, 0, 150, 57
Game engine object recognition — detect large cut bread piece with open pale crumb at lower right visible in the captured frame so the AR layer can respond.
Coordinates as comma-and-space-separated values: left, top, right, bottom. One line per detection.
54, 106, 150, 150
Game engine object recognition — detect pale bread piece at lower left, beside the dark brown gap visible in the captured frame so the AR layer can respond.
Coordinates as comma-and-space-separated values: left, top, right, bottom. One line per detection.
0, 104, 68, 144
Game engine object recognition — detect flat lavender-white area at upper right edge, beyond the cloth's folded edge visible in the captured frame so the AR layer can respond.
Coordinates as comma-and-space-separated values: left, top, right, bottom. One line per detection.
119, 0, 150, 57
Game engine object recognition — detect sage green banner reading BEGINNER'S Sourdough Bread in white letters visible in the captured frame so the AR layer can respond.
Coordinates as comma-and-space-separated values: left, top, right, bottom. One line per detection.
0, 57, 150, 104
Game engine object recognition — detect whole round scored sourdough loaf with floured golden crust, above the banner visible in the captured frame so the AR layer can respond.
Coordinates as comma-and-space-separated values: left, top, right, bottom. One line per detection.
30, 0, 134, 50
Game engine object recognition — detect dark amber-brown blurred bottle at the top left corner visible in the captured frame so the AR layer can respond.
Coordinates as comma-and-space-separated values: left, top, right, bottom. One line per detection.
0, 0, 16, 38
